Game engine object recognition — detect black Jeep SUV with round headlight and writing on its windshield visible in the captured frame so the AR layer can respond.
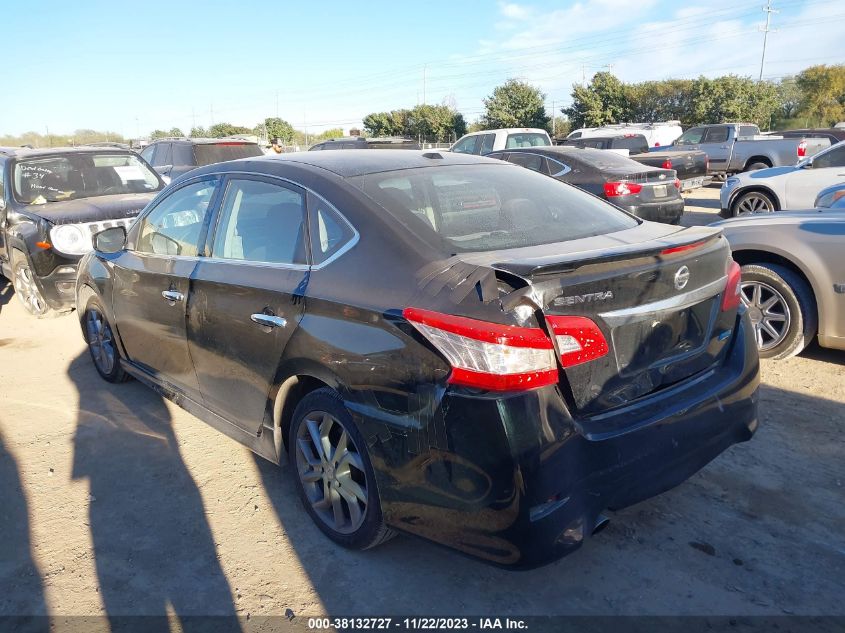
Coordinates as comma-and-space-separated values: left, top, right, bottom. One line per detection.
0, 147, 164, 316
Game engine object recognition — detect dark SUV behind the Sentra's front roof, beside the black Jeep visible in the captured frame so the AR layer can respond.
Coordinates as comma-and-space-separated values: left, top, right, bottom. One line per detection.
141, 137, 264, 178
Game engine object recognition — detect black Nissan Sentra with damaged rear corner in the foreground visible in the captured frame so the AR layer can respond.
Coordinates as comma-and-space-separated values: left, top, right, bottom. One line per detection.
77, 150, 759, 567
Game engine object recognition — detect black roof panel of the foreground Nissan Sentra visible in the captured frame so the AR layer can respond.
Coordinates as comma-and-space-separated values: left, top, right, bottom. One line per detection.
191, 149, 502, 178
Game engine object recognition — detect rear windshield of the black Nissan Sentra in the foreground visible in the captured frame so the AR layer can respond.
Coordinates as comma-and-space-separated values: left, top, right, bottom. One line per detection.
348, 164, 637, 252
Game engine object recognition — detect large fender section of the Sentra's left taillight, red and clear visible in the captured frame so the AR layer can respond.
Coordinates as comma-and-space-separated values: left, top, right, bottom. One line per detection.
402, 308, 558, 391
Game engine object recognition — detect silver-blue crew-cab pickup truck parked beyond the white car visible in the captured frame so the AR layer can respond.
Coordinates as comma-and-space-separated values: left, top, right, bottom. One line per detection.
653, 123, 830, 174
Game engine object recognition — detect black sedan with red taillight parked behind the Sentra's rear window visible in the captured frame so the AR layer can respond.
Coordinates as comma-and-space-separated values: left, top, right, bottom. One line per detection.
487, 146, 684, 224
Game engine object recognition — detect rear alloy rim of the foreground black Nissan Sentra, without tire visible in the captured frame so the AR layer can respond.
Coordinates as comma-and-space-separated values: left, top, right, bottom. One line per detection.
296, 411, 368, 534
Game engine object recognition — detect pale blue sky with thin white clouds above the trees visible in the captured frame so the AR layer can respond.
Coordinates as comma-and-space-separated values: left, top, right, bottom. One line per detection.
0, 0, 845, 137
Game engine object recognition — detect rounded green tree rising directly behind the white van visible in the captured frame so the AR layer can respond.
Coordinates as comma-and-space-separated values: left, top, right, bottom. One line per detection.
561, 72, 631, 128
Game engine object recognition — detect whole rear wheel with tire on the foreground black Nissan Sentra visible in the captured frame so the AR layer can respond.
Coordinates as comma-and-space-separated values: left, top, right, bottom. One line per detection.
288, 388, 394, 549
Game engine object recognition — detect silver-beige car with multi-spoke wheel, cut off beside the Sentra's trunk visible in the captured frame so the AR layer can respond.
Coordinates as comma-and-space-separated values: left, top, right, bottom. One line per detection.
713, 209, 845, 359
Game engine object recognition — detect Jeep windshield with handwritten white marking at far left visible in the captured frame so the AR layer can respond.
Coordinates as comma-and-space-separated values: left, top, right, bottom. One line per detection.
13, 152, 162, 204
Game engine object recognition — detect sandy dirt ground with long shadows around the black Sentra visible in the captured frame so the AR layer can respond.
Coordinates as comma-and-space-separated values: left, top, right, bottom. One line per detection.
0, 188, 845, 617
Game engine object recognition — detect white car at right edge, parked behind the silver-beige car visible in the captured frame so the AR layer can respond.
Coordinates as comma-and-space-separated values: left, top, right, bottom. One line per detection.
720, 141, 845, 218
